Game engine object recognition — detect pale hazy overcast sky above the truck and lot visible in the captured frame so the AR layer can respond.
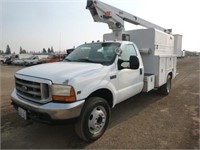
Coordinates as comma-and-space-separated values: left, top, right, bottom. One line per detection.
0, 0, 200, 53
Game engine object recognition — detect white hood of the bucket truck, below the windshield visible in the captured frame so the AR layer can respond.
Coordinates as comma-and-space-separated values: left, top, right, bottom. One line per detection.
16, 62, 103, 84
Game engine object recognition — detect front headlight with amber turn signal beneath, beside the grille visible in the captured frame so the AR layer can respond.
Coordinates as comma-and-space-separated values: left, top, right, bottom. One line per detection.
51, 85, 76, 102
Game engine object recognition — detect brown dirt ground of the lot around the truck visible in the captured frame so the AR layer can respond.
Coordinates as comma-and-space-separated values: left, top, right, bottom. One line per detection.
0, 57, 200, 149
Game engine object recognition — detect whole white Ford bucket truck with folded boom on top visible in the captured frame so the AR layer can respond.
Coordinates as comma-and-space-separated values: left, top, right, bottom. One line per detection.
11, 0, 180, 141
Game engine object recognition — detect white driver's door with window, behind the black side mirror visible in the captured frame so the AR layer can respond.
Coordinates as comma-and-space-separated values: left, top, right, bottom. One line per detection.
117, 44, 144, 103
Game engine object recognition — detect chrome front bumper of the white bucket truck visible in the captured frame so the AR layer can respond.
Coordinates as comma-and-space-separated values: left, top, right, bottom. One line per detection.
11, 90, 85, 120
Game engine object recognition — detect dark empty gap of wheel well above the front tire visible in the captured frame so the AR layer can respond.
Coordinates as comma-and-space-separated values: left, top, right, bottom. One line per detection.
88, 89, 113, 107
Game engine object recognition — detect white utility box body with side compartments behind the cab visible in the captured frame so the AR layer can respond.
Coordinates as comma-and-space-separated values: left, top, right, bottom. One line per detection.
104, 28, 177, 88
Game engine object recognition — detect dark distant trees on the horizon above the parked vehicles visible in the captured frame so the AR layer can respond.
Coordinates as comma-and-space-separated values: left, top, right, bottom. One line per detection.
0, 45, 54, 54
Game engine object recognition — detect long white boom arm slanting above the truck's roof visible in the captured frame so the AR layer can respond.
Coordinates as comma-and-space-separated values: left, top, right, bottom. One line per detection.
86, 0, 172, 34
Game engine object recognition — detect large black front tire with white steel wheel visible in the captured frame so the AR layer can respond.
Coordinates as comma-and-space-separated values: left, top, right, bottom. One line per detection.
75, 97, 110, 142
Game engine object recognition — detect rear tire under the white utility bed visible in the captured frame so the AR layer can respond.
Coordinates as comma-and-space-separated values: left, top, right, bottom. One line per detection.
159, 74, 172, 95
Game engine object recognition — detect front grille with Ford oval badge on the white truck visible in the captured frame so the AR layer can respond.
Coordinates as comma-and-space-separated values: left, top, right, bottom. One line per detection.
15, 78, 50, 103
